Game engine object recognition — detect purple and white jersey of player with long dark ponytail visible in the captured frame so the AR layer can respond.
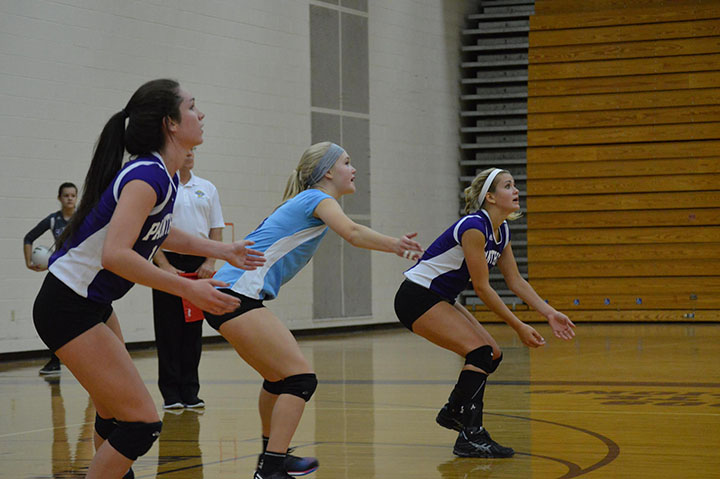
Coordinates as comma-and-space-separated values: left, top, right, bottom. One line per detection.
49, 153, 179, 303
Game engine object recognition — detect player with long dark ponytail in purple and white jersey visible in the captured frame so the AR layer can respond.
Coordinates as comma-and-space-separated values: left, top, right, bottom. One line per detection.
33, 80, 264, 479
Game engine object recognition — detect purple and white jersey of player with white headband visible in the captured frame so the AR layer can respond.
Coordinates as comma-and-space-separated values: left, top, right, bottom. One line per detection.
405, 210, 510, 302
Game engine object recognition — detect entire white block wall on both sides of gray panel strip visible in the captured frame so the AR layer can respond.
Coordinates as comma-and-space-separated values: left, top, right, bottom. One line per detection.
0, 0, 478, 353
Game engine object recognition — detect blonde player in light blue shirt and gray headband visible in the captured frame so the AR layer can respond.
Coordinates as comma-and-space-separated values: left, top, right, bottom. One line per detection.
205, 142, 422, 479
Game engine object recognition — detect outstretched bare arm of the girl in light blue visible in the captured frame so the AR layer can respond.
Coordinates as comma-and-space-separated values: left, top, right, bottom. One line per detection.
315, 198, 423, 260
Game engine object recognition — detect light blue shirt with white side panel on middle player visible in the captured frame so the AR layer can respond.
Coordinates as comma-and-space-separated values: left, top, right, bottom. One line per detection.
214, 189, 332, 300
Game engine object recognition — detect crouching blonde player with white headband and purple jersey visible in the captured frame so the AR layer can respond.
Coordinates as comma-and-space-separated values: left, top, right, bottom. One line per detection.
395, 168, 575, 458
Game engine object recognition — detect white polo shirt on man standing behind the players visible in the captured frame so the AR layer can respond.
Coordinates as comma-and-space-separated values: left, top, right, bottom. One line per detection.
167, 171, 225, 248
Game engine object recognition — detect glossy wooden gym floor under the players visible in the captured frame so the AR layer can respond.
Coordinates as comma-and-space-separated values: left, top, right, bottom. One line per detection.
0, 324, 720, 479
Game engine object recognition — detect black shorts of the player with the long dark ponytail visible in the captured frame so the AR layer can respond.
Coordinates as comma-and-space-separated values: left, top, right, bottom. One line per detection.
33, 273, 113, 352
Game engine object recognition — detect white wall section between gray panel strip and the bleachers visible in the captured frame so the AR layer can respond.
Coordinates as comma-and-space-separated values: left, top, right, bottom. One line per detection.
369, 0, 466, 334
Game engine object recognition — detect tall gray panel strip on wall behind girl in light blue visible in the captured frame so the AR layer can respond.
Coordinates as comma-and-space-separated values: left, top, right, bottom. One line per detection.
310, 2, 372, 319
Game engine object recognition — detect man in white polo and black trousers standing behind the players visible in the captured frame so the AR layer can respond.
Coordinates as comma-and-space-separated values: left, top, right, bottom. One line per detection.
153, 149, 225, 409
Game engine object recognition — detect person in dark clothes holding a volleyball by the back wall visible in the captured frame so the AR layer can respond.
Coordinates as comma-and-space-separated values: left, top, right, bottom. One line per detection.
23, 182, 77, 375
